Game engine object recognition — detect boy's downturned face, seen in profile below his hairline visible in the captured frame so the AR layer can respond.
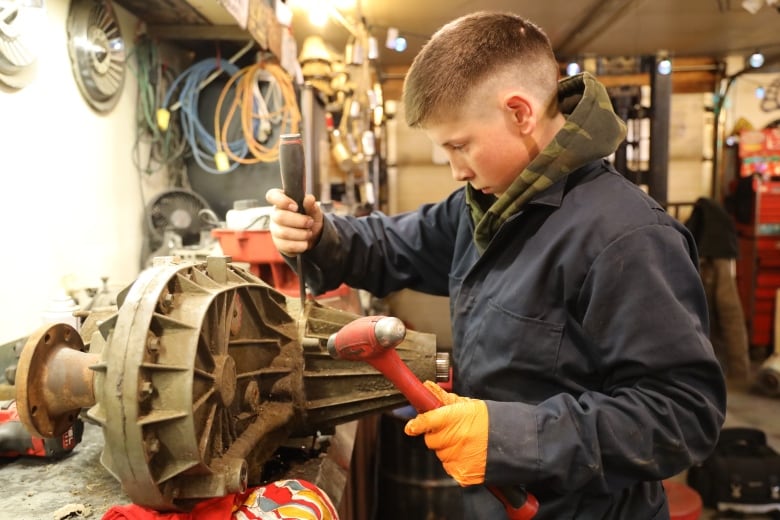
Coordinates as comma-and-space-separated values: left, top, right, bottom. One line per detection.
424, 91, 534, 196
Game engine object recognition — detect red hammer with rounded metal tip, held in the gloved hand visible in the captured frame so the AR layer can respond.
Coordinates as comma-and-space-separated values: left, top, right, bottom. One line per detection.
328, 316, 539, 520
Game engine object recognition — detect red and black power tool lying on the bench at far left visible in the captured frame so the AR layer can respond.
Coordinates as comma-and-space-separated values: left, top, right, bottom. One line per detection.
0, 399, 84, 458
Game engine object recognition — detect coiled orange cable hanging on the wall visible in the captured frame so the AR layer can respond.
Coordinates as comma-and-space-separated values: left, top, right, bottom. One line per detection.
214, 61, 301, 165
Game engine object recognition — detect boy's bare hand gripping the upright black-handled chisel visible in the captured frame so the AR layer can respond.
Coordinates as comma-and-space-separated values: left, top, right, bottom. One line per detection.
265, 188, 323, 256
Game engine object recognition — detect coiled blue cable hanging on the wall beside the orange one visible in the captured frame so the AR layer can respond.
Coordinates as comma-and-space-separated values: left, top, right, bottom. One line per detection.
163, 58, 249, 174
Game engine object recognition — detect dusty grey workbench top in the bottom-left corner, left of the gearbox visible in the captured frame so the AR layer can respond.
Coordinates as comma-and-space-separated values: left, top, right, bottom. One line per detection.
0, 423, 130, 520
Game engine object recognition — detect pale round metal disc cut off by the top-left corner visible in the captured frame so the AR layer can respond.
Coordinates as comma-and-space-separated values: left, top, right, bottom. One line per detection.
0, 0, 41, 88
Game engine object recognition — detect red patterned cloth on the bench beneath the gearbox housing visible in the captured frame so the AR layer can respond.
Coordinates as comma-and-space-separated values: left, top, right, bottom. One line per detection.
102, 480, 338, 520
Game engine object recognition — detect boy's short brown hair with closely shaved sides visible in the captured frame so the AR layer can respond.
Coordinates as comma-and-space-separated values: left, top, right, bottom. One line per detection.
403, 11, 558, 127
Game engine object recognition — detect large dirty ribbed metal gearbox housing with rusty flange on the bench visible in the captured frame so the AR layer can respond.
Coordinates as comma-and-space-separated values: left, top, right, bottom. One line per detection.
19, 257, 436, 511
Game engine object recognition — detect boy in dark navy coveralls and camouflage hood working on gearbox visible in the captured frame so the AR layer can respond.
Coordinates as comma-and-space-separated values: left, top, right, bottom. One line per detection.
266, 12, 726, 519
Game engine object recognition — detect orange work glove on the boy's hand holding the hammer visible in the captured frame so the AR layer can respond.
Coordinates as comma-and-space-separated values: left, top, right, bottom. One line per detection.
404, 381, 489, 486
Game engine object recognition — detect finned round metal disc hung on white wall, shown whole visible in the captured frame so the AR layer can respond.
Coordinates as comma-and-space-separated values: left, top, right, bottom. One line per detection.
68, 0, 126, 112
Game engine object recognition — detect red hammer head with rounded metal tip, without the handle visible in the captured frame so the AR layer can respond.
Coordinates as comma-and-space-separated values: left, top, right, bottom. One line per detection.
328, 316, 406, 361
